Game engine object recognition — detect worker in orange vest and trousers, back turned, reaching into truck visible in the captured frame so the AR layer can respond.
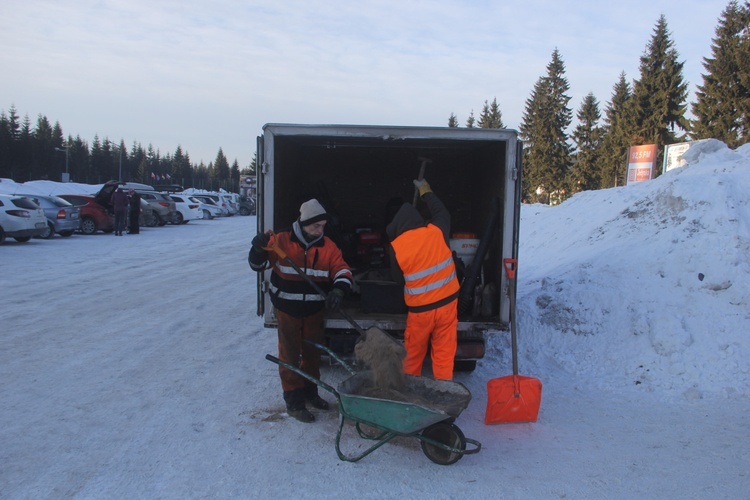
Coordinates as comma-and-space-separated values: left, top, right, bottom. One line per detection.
386, 179, 459, 380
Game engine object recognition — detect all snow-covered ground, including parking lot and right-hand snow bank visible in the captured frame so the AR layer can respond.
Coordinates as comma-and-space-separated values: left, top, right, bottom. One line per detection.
0, 141, 750, 499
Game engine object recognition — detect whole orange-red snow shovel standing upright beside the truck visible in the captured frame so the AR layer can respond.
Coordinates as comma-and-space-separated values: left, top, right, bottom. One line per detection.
484, 259, 542, 424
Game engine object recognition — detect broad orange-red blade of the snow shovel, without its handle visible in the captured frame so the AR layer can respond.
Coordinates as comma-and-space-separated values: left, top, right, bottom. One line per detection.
484, 375, 542, 425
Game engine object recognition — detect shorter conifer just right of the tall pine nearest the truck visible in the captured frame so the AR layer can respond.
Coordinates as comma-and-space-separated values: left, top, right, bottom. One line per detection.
568, 93, 602, 194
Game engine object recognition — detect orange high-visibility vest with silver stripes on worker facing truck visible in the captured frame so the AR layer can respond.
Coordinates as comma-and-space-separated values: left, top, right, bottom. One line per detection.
391, 224, 459, 308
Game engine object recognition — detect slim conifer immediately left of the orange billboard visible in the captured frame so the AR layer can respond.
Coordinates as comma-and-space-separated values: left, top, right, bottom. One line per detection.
599, 72, 632, 189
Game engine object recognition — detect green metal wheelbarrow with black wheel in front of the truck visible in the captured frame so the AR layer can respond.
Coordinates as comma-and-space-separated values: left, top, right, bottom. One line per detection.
266, 342, 482, 465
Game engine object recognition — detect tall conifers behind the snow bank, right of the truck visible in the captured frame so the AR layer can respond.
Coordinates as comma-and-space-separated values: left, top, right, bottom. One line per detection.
448, 0, 750, 203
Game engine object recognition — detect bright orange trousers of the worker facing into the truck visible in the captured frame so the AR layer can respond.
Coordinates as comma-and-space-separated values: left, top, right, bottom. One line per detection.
404, 300, 458, 380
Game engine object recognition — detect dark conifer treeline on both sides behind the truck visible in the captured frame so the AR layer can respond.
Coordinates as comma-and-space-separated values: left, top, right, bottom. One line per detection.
0, 0, 750, 203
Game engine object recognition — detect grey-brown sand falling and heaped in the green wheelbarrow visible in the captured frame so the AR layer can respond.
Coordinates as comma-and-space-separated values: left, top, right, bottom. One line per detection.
352, 327, 470, 415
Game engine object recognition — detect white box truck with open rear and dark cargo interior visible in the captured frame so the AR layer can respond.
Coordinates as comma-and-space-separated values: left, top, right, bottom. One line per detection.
257, 124, 522, 370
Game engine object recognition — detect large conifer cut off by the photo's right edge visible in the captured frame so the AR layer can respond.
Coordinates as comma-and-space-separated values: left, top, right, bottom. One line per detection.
691, 0, 750, 149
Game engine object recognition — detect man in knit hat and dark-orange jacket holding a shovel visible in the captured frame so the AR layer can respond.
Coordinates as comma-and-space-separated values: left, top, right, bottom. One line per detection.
248, 199, 353, 422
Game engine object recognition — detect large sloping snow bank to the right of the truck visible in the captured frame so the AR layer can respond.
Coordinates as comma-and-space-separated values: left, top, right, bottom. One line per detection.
518, 140, 750, 398
